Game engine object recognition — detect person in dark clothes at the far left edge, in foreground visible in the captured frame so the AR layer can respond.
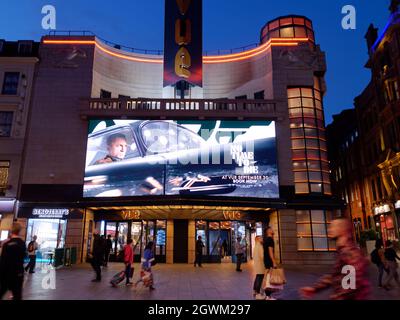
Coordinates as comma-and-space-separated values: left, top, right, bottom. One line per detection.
0, 222, 26, 300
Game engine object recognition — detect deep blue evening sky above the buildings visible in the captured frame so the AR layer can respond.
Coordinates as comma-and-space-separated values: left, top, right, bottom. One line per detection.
0, 0, 390, 123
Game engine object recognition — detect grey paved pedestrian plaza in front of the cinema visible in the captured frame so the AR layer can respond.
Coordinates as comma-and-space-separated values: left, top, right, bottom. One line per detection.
14, 262, 400, 300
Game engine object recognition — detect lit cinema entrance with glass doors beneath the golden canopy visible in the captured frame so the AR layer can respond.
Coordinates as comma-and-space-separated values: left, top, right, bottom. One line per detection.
91, 206, 269, 263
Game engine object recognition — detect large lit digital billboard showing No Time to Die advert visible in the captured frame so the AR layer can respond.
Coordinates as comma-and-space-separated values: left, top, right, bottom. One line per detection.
83, 120, 279, 198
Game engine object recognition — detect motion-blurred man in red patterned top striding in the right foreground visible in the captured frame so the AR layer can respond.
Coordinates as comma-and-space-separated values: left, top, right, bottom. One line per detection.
300, 219, 370, 300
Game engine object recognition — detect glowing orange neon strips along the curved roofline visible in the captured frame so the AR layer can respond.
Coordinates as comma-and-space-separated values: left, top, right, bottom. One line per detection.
43, 38, 310, 64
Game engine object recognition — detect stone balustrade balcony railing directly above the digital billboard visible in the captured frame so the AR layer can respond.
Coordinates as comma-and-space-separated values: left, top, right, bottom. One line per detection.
81, 98, 276, 117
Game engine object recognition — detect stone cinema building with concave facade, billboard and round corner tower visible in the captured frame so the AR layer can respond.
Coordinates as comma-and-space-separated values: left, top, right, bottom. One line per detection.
3, 10, 342, 265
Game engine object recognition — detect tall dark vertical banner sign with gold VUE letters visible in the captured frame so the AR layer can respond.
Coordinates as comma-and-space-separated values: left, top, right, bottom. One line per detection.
164, 0, 203, 87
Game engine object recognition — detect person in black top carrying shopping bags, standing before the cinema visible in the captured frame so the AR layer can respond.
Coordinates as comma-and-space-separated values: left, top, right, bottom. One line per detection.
263, 227, 286, 300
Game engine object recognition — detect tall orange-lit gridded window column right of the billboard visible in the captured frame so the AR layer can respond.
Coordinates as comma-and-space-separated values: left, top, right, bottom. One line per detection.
288, 77, 331, 195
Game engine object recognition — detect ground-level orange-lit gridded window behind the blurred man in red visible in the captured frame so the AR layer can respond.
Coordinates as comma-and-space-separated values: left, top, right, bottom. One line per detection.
296, 210, 336, 251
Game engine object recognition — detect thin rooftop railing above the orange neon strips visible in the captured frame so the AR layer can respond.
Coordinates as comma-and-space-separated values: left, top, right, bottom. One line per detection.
49, 30, 260, 56
